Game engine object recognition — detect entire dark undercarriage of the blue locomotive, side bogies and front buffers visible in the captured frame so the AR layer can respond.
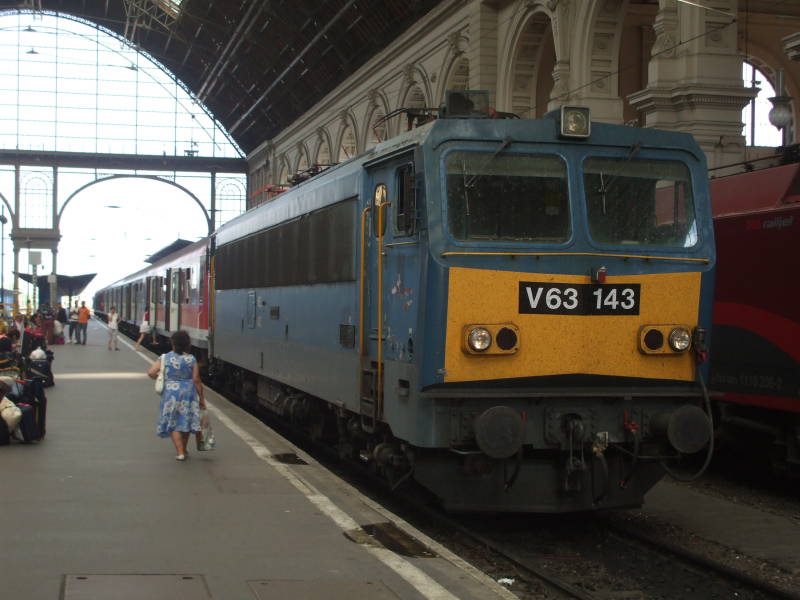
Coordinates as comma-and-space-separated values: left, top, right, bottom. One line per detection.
211, 356, 710, 512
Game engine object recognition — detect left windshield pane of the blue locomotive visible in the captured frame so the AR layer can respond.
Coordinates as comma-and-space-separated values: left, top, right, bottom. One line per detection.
446, 151, 570, 243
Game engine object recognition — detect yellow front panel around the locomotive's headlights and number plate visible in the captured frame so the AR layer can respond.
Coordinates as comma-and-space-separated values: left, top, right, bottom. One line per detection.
445, 268, 700, 383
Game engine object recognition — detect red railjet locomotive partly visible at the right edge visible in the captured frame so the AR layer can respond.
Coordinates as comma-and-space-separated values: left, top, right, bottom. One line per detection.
710, 164, 800, 464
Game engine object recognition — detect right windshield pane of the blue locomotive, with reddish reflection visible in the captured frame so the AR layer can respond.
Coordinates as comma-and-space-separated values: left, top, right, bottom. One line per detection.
584, 158, 697, 248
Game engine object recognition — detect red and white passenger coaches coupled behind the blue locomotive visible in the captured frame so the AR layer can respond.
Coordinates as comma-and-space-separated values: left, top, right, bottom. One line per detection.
94, 239, 209, 359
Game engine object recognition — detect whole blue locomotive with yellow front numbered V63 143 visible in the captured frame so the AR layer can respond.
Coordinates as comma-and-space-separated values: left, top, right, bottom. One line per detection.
209, 93, 715, 512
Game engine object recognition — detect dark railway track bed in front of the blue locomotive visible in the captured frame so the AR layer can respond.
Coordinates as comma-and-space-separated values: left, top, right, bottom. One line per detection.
406, 506, 800, 600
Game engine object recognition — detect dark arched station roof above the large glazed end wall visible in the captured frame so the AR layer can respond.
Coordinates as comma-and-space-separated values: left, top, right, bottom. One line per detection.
0, 0, 442, 153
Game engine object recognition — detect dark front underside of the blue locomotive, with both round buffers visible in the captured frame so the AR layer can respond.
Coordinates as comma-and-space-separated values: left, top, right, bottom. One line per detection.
414, 393, 711, 512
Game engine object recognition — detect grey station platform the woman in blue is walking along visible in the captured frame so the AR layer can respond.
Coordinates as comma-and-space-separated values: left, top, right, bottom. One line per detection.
0, 321, 515, 600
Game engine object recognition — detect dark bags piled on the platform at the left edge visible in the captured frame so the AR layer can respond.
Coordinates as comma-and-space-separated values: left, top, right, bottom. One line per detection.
0, 370, 47, 446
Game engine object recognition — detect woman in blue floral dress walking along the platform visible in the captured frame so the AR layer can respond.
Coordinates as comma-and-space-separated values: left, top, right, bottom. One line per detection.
147, 331, 206, 461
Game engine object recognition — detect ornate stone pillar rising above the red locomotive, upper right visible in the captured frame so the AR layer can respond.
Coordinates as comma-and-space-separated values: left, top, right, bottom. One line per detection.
628, 0, 755, 167
